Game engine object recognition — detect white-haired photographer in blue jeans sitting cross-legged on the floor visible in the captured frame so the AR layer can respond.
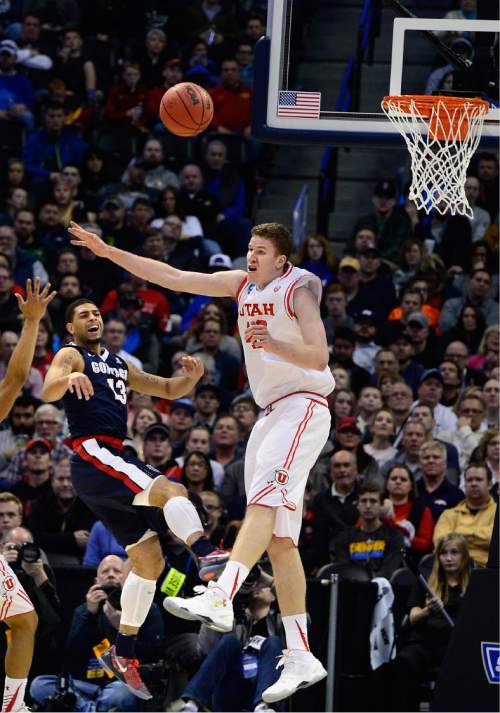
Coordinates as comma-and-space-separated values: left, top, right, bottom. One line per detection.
30, 555, 164, 711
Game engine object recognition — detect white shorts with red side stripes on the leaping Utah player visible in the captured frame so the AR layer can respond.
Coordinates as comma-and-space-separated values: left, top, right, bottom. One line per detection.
245, 391, 331, 545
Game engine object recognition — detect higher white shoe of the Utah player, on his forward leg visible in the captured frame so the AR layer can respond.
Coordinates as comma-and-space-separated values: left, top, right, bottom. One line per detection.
163, 582, 234, 632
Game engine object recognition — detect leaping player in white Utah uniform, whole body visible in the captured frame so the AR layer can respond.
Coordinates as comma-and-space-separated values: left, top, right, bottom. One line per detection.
69, 223, 335, 703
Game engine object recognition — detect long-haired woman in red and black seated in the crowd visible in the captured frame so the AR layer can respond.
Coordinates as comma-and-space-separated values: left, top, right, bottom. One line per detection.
385, 463, 434, 562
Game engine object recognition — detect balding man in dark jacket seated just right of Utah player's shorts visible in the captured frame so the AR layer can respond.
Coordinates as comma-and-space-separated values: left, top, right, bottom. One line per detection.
301, 450, 358, 570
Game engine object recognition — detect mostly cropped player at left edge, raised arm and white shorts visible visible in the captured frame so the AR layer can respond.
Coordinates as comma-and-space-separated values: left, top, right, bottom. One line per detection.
0, 278, 56, 712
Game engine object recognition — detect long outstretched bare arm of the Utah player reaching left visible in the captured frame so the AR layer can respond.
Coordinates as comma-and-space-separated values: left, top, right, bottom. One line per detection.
68, 222, 246, 297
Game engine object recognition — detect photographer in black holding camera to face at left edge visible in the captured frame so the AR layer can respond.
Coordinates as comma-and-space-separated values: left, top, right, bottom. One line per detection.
0, 527, 61, 676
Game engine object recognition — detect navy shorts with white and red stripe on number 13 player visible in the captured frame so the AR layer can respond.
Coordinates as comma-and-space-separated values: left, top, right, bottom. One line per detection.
71, 436, 167, 547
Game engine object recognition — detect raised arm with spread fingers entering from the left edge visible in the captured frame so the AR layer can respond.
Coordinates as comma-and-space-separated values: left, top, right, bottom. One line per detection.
0, 278, 56, 421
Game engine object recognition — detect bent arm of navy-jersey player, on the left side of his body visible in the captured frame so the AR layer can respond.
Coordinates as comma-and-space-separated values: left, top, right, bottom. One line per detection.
42, 347, 94, 401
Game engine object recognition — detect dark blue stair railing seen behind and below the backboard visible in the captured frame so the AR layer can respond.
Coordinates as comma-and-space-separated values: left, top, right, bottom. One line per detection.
316, 0, 382, 235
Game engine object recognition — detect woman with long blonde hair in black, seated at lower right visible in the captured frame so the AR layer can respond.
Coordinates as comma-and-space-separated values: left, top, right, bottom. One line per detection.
370, 533, 471, 711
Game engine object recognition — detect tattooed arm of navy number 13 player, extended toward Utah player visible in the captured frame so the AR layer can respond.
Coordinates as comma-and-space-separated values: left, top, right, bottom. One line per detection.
128, 357, 204, 399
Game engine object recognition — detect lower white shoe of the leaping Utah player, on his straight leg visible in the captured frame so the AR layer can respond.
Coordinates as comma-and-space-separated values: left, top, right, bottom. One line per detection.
262, 649, 327, 703
